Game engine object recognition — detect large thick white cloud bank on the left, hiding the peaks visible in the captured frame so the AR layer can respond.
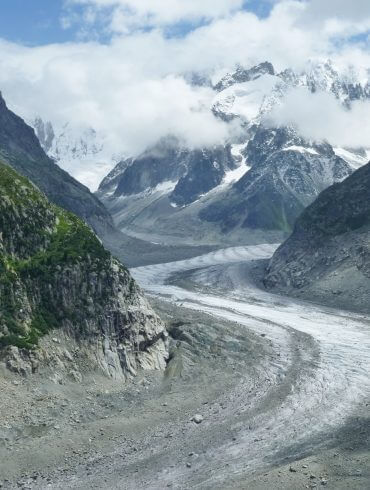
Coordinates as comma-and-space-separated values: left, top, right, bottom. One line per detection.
0, 39, 227, 154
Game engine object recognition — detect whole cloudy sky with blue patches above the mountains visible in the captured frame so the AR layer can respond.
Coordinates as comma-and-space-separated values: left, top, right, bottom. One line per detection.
0, 0, 370, 186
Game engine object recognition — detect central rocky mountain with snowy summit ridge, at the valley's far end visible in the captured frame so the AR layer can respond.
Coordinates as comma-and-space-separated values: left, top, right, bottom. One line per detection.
97, 62, 369, 244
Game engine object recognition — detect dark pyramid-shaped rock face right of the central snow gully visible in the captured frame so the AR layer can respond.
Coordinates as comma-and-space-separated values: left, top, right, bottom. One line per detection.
200, 127, 352, 233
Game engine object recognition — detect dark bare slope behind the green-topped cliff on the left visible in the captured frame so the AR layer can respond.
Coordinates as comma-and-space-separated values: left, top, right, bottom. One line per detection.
0, 94, 113, 237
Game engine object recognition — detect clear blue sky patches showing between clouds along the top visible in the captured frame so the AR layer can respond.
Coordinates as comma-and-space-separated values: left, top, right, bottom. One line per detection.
0, 0, 271, 46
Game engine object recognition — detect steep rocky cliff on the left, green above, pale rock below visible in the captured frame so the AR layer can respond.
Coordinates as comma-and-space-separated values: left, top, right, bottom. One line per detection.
0, 163, 166, 379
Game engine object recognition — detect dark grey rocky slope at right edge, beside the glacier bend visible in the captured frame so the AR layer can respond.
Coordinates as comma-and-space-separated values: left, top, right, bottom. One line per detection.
265, 163, 370, 312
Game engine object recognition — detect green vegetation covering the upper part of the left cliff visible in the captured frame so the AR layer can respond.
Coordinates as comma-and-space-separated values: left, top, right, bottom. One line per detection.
0, 163, 111, 349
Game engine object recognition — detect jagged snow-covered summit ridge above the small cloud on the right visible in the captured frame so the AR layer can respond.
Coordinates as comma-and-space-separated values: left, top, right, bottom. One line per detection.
212, 61, 370, 131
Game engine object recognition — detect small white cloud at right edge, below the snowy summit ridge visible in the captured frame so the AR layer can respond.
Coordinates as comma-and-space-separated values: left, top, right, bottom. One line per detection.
265, 88, 370, 148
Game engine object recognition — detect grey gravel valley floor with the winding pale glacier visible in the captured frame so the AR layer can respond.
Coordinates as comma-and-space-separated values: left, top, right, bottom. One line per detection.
0, 245, 370, 490
